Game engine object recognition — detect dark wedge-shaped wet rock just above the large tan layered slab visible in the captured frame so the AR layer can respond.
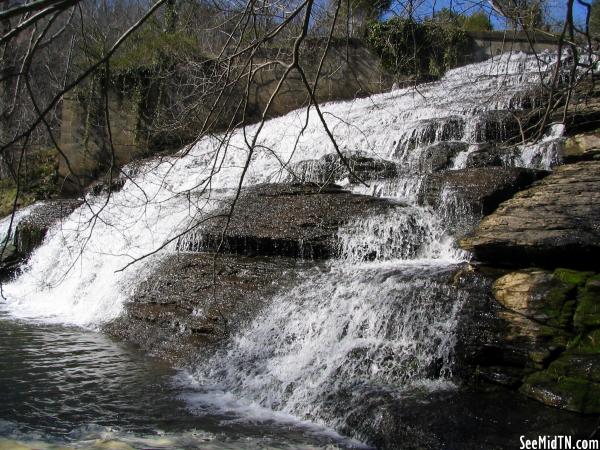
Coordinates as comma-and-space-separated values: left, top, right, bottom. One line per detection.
419, 167, 547, 214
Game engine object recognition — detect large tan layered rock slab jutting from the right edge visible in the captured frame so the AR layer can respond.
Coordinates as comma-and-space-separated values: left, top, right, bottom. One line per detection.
461, 161, 600, 268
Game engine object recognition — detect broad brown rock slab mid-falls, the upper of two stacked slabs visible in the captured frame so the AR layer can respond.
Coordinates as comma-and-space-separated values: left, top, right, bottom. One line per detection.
178, 184, 400, 259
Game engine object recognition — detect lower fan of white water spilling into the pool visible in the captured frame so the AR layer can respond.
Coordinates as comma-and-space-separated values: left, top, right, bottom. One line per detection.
195, 261, 464, 426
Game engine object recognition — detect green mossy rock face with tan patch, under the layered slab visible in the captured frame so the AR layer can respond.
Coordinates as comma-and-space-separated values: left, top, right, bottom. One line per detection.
465, 269, 600, 414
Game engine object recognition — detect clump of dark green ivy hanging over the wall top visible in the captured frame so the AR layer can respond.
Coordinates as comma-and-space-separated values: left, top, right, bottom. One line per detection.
367, 18, 468, 78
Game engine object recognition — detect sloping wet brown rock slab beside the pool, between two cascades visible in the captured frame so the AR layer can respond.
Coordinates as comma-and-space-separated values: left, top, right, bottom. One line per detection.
105, 253, 309, 365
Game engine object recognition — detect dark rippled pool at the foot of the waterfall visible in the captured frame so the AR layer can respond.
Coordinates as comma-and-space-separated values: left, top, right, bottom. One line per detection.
0, 316, 360, 450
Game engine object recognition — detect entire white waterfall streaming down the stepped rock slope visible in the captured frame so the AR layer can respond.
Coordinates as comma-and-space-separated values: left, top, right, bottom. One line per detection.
3, 53, 568, 436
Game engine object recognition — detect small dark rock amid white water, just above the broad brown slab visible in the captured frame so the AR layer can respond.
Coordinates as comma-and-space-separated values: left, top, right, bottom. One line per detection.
287, 152, 398, 184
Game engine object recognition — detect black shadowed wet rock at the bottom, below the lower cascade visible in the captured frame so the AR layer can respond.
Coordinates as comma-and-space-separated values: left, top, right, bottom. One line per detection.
328, 386, 597, 450
